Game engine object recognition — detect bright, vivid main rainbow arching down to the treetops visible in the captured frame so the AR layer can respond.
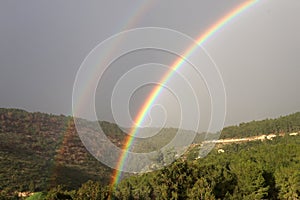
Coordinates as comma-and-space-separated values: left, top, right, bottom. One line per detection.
111, 0, 258, 189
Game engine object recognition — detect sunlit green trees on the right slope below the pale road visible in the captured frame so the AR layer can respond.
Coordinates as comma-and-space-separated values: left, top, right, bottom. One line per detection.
114, 136, 300, 199
